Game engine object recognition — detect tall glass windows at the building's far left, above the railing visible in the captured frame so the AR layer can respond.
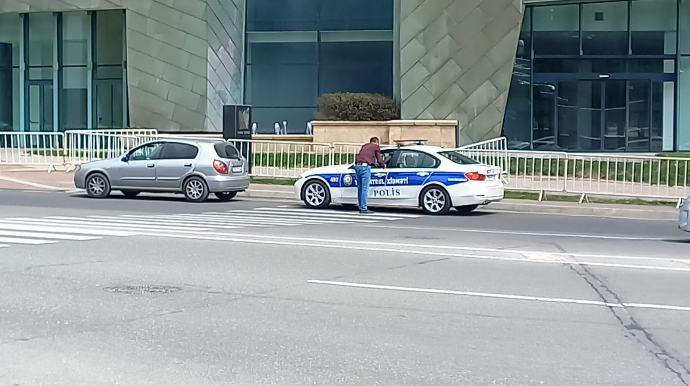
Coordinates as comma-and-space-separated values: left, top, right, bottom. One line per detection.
0, 10, 128, 132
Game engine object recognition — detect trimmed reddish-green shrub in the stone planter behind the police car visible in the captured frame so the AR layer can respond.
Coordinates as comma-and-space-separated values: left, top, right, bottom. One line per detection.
316, 93, 400, 121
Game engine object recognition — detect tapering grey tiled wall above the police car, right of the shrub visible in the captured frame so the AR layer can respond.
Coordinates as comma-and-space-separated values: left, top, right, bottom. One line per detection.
400, 0, 523, 144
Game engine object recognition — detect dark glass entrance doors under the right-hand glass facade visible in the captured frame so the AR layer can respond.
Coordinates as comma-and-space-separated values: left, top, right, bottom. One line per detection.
533, 74, 674, 152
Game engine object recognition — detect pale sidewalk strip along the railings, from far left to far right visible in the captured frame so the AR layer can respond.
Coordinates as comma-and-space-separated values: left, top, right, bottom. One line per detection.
0, 165, 678, 221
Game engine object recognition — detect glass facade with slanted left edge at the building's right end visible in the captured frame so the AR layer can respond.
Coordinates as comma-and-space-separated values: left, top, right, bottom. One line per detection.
503, 0, 690, 153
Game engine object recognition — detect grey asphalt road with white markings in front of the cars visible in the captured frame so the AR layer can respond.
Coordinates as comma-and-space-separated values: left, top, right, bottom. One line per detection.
0, 191, 690, 386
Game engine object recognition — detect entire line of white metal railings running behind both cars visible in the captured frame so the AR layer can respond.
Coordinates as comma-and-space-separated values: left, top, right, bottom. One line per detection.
0, 129, 690, 199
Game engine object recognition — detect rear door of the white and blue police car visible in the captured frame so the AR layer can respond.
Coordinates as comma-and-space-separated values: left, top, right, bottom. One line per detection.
387, 149, 440, 206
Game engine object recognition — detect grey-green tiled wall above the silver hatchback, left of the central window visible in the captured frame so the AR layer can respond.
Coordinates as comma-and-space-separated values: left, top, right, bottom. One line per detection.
0, 0, 245, 131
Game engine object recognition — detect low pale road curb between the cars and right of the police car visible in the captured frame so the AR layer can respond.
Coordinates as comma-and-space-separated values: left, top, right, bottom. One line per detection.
240, 187, 678, 221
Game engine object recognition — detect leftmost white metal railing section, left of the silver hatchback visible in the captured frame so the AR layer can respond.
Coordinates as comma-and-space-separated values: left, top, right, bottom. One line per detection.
0, 132, 63, 168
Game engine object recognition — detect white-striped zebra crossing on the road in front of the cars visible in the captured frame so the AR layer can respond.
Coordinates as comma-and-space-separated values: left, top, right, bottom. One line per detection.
0, 205, 421, 248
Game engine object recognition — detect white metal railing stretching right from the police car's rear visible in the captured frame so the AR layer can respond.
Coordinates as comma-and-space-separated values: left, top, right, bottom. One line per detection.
458, 150, 690, 201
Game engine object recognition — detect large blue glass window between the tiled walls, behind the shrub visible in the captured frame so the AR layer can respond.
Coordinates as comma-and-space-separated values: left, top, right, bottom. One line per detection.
245, 0, 394, 134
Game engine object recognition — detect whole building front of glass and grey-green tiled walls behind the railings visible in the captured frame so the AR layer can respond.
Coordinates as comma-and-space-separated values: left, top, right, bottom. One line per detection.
0, 0, 690, 153
